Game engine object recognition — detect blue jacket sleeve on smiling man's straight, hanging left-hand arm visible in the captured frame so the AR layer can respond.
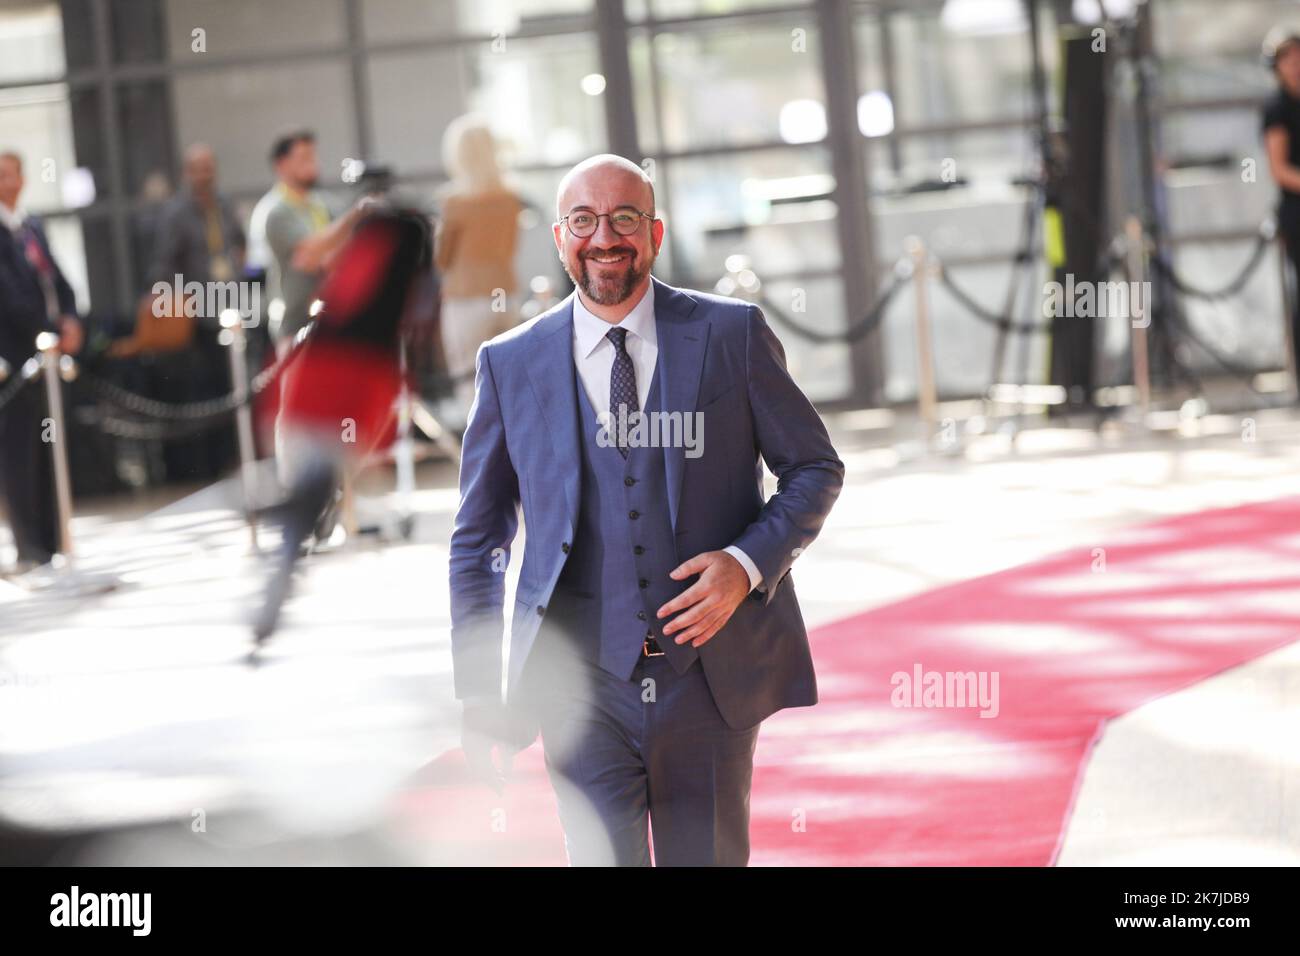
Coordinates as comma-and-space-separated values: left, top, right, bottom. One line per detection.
449, 345, 519, 698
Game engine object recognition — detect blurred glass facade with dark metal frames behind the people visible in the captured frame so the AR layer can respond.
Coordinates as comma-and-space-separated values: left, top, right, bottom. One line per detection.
0, 0, 1292, 406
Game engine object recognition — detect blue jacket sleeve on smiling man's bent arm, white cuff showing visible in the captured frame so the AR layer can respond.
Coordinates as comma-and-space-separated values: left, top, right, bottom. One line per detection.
733, 306, 844, 605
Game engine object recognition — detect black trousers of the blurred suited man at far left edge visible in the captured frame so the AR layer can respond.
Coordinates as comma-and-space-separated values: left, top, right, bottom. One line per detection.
0, 382, 59, 564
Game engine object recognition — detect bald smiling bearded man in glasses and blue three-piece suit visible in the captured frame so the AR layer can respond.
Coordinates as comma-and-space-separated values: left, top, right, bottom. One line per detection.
450, 155, 844, 866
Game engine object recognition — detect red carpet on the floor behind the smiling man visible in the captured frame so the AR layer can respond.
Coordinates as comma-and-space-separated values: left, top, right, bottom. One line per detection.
402, 498, 1300, 866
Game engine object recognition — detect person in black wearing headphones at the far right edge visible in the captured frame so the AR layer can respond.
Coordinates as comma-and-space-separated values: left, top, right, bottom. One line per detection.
1262, 26, 1300, 392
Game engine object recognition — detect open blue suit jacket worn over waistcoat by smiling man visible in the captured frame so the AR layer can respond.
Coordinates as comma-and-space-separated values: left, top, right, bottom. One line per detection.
450, 278, 844, 728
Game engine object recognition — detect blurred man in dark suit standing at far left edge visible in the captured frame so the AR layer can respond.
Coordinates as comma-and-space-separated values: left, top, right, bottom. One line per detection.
0, 151, 83, 571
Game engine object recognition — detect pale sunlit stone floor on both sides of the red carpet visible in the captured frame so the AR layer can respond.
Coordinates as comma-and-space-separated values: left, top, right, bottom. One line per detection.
0, 400, 1300, 865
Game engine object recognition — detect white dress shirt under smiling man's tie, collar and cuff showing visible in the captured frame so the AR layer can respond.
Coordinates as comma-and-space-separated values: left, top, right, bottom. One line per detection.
573, 282, 763, 591
